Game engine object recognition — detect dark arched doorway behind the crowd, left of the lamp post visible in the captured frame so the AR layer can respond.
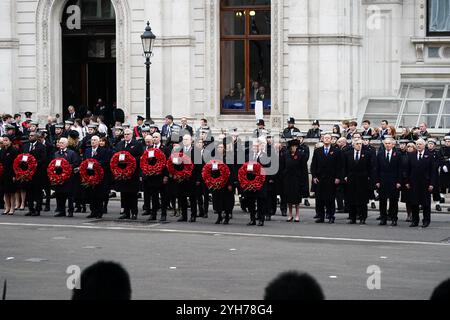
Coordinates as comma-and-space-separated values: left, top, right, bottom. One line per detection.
61, 0, 117, 120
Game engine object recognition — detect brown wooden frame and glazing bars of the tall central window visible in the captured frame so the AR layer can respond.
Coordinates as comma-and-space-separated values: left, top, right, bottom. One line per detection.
219, 1, 272, 115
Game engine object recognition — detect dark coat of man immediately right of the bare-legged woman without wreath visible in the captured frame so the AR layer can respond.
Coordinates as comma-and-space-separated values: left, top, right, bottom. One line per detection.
311, 146, 343, 201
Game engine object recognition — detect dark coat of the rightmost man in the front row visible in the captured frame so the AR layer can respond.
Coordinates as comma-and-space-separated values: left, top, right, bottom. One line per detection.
405, 151, 436, 205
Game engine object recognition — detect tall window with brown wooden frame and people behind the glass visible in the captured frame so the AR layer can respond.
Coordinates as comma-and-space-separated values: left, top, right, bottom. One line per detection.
220, 0, 271, 113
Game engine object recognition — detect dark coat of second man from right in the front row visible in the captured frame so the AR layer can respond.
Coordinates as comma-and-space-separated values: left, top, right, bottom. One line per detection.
375, 149, 403, 199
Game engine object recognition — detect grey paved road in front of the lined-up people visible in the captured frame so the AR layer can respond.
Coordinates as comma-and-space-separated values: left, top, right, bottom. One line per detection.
0, 201, 450, 299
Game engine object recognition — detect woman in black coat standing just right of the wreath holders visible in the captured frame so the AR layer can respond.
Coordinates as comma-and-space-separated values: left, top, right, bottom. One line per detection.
283, 140, 308, 222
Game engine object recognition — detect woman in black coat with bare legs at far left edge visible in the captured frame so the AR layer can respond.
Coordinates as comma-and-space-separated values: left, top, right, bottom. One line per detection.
0, 135, 19, 215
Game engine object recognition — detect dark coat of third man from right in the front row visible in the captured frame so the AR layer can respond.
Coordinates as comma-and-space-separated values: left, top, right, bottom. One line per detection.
343, 150, 374, 205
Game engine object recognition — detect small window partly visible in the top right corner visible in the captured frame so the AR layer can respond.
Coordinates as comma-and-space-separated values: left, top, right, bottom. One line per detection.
427, 0, 450, 36
